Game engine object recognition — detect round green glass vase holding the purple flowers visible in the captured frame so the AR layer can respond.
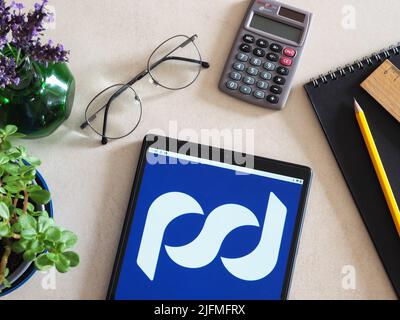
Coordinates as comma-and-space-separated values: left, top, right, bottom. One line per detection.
0, 57, 75, 139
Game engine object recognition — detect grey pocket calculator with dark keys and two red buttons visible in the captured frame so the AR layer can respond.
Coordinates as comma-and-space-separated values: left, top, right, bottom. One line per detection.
219, 0, 312, 110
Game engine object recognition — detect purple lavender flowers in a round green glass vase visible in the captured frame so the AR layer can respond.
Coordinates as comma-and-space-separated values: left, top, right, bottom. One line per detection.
0, 0, 75, 138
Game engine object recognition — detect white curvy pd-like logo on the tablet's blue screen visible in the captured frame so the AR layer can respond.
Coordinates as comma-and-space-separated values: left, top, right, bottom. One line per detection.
137, 192, 287, 281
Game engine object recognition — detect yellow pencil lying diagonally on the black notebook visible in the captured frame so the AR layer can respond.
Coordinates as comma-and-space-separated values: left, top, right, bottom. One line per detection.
354, 99, 400, 235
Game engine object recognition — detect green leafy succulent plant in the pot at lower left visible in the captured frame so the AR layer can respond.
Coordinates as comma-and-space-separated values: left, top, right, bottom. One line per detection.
0, 125, 79, 291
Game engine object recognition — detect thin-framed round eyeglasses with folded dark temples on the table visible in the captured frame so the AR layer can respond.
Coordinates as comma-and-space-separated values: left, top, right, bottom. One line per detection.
81, 35, 210, 145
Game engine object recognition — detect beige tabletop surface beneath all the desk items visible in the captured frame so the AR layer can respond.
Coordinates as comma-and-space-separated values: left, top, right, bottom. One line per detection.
1, 0, 400, 299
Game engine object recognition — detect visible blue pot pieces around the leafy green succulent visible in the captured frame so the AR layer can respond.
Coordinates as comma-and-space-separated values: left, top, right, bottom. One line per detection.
0, 172, 54, 297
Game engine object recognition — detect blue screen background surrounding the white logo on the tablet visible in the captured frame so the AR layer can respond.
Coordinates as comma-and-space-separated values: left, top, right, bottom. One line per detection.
115, 152, 303, 300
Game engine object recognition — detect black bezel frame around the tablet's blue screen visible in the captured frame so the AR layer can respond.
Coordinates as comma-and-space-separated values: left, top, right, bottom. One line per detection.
106, 135, 312, 300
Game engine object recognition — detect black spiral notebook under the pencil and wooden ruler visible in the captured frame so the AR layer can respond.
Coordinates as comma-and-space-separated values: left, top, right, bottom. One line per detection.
304, 43, 400, 298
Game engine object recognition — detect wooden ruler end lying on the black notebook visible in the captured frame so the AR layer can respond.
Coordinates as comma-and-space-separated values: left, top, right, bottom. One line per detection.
361, 60, 400, 122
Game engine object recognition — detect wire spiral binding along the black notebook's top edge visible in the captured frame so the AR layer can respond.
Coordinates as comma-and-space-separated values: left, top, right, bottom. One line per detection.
310, 42, 400, 88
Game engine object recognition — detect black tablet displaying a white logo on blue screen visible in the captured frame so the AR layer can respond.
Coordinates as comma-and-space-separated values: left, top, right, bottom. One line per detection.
107, 135, 312, 300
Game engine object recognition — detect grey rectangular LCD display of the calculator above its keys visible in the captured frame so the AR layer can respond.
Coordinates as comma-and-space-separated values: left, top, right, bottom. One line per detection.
250, 14, 303, 42
